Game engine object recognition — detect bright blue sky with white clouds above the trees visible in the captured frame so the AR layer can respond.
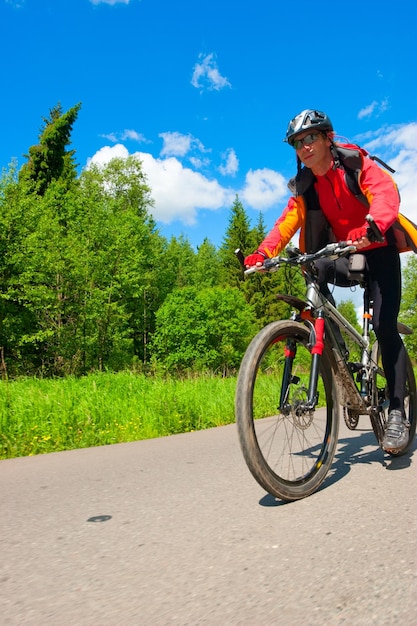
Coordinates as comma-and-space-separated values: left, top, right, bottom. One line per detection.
0, 0, 417, 256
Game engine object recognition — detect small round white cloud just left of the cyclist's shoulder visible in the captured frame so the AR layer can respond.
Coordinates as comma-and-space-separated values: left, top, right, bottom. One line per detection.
239, 168, 288, 210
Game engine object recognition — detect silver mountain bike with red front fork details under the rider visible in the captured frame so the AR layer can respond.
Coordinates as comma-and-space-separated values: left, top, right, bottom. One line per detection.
235, 228, 417, 501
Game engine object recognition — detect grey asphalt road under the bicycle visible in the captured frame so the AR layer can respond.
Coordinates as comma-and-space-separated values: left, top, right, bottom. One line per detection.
0, 410, 417, 626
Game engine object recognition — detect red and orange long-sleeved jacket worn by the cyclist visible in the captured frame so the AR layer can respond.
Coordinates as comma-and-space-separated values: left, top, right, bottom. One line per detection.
258, 145, 417, 257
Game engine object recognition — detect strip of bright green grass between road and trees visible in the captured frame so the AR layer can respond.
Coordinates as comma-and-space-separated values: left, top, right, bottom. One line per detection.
0, 372, 236, 459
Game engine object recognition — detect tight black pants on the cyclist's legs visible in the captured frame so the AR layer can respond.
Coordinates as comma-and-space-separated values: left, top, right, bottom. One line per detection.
316, 246, 407, 411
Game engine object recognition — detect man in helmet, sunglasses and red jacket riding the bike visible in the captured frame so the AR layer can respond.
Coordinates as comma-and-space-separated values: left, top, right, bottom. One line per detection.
245, 109, 409, 451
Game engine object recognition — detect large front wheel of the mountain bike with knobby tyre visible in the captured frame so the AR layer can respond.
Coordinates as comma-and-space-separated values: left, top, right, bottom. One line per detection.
235, 320, 339, 500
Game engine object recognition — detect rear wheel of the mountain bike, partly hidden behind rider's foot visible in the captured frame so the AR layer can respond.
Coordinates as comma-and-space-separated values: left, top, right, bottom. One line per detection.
371, 341, 417, 456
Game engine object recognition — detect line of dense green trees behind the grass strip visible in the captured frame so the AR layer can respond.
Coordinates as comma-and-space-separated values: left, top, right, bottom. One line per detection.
0, 104, 416, 376
